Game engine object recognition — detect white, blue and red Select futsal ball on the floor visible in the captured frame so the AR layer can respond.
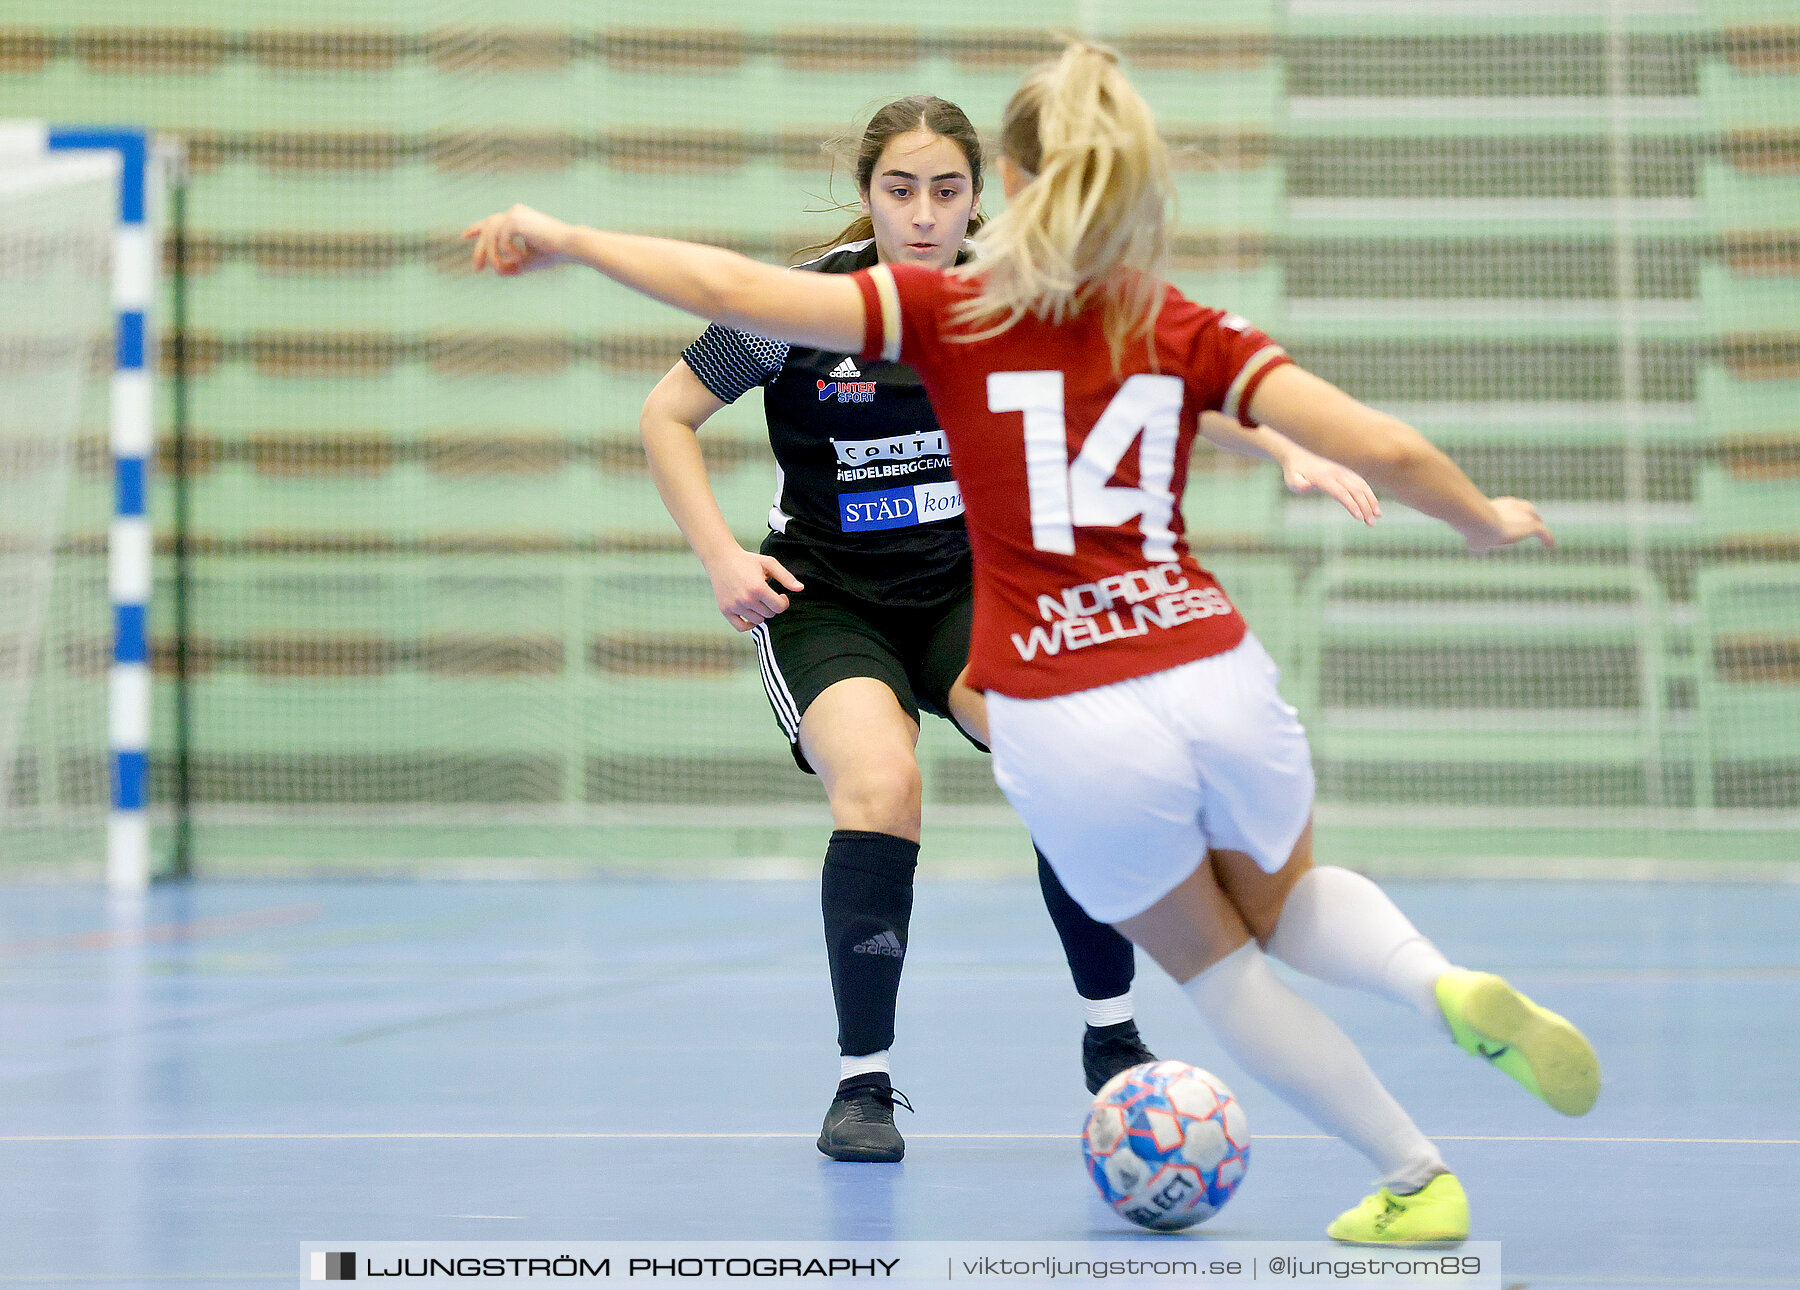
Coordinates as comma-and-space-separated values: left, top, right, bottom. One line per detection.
1082, 1062, 1249, 1232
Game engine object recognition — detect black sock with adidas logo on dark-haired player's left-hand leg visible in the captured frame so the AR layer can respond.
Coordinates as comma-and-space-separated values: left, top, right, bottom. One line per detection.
819, 829, 918, 1058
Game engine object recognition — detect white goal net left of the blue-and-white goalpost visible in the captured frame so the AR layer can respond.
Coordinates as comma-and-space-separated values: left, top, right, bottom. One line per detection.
0, 157, 119, 878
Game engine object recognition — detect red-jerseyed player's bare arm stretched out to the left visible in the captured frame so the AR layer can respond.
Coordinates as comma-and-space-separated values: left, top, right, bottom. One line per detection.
463, 205, 862, 354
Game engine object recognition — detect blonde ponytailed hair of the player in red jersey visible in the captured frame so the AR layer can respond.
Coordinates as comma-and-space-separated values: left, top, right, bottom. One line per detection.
950, 40, 1174, 371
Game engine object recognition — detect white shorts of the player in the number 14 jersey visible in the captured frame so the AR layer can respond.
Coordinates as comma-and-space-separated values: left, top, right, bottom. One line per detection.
988, 633, 1314, 923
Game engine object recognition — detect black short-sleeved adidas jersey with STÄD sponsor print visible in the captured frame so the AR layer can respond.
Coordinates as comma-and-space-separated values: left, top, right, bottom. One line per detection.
682, 239, 972, 608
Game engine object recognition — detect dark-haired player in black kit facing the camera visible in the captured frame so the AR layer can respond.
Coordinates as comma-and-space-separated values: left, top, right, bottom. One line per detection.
641, 95, 1375, 1160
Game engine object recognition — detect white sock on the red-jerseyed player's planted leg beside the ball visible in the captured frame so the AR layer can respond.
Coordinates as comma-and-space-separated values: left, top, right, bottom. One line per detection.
1183, 941, 1445, 1191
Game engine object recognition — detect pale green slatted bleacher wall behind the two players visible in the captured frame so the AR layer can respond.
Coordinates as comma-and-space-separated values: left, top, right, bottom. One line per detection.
0, 0, 1800, 873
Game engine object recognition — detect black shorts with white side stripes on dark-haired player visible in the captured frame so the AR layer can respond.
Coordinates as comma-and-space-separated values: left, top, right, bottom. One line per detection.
751, 587, 986, 775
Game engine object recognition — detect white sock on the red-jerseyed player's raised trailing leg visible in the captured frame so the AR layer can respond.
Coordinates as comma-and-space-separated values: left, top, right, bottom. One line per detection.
1269, 867, 1451, 1035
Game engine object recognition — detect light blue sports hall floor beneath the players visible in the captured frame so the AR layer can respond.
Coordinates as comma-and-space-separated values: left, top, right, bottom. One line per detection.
0, 882, 1800, 1290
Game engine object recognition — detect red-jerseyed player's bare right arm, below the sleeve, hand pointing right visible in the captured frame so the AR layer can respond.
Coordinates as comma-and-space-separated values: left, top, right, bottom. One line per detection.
1249, 363, 1553, 551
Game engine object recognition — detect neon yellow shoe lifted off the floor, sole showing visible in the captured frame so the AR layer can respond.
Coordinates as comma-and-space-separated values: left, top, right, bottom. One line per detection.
1436, 970, 1600, 1115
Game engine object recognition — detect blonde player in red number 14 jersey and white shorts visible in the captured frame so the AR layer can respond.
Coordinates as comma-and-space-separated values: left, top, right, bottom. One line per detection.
466, 41, 1600, 1245
